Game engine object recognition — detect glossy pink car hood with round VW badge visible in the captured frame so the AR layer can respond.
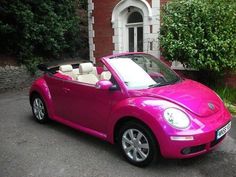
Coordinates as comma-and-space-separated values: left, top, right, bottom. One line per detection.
129, 80, 222, 117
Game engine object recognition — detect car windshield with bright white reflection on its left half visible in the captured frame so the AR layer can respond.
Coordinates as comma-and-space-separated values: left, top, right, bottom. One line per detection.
108, 54, 180, 89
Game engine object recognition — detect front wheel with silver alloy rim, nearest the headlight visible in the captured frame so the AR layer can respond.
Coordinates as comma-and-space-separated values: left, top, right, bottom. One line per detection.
118, 121, 158, 167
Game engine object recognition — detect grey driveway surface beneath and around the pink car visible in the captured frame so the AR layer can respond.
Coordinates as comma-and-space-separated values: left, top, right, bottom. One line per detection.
0, 90, 236, 177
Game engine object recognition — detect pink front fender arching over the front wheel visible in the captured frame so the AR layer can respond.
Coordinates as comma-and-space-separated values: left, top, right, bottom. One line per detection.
107, 97, 167, 144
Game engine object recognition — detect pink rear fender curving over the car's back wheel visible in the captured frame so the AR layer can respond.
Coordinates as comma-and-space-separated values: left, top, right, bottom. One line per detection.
30, 77, 54, 118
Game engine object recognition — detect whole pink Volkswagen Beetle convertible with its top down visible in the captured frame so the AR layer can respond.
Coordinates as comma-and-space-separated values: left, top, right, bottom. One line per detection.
30, 53, 231, 166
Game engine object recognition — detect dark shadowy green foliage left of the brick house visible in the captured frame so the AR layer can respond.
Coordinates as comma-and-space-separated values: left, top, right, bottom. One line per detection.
0, 0, 82, 72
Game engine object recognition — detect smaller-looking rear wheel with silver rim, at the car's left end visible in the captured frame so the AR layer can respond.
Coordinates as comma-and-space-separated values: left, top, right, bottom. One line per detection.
31, 94, 49, 123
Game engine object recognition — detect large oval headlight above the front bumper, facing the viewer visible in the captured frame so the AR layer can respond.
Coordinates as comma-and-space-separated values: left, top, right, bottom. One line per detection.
163, 108, 190, 129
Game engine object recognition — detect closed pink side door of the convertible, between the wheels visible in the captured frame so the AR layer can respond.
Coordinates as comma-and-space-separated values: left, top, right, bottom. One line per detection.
60, 81, 119, 133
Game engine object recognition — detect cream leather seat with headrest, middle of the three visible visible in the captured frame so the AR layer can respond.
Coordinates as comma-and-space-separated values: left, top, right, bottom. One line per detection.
77, 63, 98, 85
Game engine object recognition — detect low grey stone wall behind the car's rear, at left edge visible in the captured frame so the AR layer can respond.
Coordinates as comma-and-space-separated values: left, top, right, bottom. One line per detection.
0, 65, 40, 92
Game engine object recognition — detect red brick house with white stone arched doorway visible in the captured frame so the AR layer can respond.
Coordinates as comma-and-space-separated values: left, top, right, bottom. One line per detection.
88, 0, 167, 63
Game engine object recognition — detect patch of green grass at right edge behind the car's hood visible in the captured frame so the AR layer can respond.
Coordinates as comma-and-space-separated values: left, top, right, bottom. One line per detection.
213, 87, 236, 116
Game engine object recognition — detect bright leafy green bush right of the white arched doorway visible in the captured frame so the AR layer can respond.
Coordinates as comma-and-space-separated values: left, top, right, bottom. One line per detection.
160, 0, 236, 72
